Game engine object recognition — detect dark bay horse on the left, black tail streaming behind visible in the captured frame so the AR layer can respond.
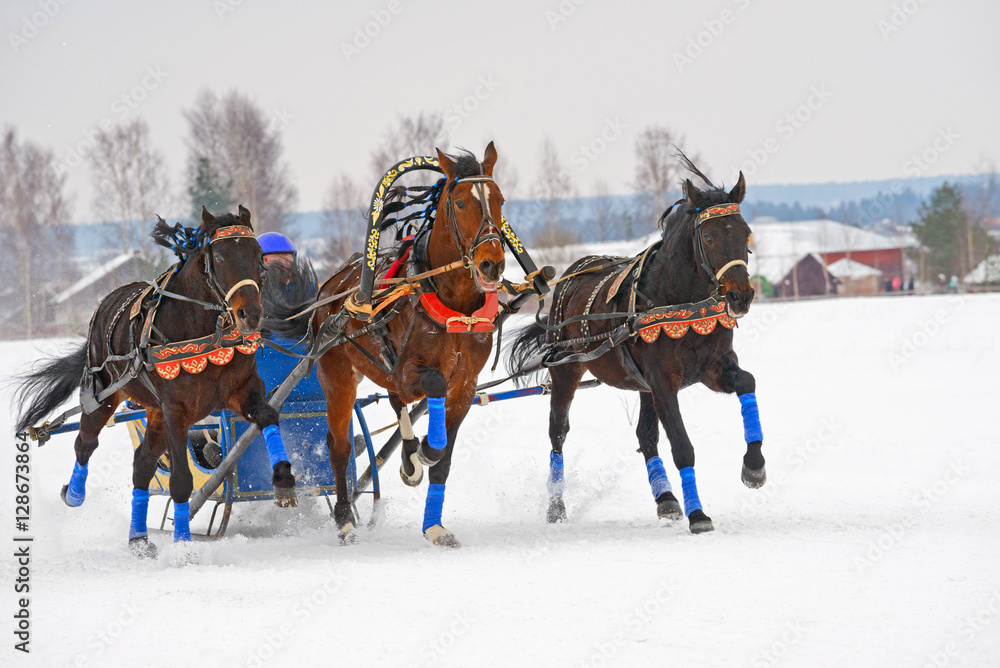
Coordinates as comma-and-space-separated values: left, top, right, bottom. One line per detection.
17, 206, 295, 558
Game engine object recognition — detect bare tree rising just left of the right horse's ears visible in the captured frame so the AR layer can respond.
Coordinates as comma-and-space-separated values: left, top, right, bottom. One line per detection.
635, 125, 698, 229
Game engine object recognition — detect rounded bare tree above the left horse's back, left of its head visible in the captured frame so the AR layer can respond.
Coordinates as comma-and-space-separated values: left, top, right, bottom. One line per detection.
88, 118, 170, 253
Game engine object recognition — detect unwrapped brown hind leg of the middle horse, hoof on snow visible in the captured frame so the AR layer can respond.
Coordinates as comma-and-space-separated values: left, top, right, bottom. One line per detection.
318, 353, 358, 544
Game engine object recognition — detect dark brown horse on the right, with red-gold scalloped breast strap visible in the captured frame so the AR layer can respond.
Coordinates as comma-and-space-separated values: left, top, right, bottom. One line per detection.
507, 164, 766, 533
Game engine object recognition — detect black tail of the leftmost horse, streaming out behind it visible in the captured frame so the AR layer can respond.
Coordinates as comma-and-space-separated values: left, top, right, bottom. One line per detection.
14, 341, 87, 433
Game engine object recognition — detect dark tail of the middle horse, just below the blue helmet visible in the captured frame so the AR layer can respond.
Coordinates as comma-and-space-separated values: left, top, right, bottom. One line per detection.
260, 259, 319, 339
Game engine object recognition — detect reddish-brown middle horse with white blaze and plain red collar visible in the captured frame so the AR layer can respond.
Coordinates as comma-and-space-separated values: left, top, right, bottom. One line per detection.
265, 142, 504, 547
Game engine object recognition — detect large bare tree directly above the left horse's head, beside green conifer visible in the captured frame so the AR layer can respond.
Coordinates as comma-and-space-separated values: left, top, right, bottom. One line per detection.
184, 91, 298, 232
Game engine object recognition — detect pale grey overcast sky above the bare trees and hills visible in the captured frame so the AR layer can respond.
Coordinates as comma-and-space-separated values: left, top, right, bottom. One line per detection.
0, 0, 1000, 220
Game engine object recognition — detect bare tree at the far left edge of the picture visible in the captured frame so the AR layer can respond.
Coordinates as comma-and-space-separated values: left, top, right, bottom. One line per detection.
0, 128, 69, 337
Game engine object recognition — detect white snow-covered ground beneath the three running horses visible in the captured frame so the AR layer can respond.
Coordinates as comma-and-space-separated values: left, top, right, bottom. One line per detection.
0, 295, 1000, 668
